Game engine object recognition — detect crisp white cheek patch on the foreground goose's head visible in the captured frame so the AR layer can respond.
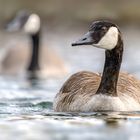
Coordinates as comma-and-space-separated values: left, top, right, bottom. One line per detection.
94, 27, 118, 50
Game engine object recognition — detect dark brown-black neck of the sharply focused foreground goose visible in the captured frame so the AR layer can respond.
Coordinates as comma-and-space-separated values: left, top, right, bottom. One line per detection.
96, 34, 123, 96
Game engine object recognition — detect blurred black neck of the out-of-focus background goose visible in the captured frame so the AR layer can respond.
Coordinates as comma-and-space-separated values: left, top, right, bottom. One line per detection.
28, 31, 40, 72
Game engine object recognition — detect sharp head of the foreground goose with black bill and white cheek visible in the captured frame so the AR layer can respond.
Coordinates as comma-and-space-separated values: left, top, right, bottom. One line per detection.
72, 21, 120, 50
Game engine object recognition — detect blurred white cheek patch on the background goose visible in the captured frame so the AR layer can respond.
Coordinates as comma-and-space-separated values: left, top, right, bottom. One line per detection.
24, 14, 40, 34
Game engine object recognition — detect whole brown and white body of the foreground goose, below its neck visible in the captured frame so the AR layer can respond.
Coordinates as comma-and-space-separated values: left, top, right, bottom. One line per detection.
54, 71, 140, 112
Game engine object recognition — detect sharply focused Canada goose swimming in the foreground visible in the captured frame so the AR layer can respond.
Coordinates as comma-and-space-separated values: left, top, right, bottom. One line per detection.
53, 21, 140, 112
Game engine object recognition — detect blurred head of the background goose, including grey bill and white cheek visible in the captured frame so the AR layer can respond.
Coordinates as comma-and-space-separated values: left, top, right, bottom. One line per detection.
6, 11, 41, 35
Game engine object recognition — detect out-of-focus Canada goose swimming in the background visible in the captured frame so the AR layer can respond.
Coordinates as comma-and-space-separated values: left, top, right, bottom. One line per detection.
1, 11, 67, 77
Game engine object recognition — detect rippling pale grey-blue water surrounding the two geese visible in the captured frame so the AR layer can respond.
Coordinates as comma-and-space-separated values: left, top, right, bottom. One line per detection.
0, 25, 140, 140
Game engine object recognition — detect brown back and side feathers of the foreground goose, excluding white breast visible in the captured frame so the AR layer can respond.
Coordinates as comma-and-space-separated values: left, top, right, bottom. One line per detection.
54, 71, 140, 112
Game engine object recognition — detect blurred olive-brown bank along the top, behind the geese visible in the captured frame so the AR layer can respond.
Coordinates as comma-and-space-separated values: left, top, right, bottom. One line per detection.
0, 0, 140, 24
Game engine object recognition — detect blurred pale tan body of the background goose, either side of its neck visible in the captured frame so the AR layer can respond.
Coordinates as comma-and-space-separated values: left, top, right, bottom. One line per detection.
0, 45, 67, 77
